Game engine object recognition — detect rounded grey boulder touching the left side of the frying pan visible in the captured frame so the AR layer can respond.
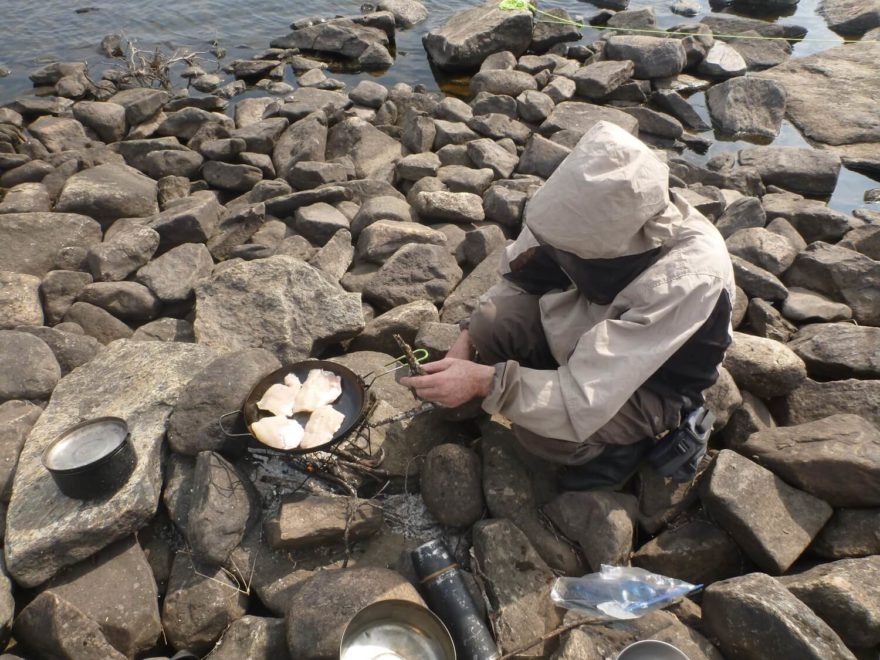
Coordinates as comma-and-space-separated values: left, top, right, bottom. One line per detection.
168, 348, 281, 456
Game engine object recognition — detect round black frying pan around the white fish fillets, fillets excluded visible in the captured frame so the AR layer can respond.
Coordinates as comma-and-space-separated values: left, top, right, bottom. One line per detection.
219, 351, 428, 455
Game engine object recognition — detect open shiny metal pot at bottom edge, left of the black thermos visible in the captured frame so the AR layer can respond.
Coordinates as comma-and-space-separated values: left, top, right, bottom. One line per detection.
339, 600, 456, 660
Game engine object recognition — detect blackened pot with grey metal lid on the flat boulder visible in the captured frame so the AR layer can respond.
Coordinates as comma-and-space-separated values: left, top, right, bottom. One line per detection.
43, 417, 137, 500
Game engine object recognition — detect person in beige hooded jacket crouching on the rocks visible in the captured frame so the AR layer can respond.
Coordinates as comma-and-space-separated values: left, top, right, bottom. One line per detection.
402, 121, 735, 487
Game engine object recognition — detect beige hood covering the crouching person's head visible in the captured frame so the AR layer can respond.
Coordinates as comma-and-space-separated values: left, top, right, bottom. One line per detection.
525, 121, 683, 259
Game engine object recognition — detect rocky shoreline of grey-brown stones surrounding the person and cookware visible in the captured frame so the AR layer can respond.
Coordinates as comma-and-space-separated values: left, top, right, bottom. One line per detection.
0, 0, 880, 660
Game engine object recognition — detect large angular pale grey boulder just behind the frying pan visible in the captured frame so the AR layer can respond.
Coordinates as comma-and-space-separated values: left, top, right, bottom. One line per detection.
194, 255, 364, 363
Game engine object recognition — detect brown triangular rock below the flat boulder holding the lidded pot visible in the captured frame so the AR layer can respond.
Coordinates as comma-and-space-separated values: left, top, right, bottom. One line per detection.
43, 537, 162, 657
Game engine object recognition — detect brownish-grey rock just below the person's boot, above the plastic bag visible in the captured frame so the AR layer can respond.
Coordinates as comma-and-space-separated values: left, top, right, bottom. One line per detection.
544, 492, 638, 571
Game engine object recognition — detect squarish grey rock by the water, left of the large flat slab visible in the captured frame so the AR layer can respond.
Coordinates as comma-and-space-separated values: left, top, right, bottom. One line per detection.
706, 77, 785, 139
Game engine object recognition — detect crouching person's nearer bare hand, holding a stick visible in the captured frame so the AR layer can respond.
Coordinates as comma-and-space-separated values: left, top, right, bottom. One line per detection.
400, 357, 495, 408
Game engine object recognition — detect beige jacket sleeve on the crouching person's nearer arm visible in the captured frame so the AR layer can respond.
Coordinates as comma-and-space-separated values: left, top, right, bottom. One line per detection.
483, 272, 724, 442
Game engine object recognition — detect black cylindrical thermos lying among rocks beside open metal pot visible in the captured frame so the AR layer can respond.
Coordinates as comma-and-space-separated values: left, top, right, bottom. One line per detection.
412, 539, 500, 660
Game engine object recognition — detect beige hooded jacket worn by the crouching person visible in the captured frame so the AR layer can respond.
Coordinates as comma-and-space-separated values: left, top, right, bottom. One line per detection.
483, 122, 735, 442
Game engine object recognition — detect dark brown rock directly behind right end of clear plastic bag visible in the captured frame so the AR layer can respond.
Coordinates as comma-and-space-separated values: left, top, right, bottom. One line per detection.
632, 519, 743, 585
